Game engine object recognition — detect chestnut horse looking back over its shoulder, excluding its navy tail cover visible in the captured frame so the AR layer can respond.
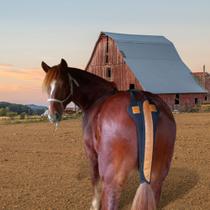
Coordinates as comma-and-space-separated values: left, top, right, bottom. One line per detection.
41, 59, 176, 210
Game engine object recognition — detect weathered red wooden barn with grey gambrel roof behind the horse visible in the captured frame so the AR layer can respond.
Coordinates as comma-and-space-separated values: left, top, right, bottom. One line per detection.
86, 32, 206, 110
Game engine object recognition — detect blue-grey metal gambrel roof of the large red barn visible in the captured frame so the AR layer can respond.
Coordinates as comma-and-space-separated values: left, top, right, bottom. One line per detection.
102, 32, 207, 93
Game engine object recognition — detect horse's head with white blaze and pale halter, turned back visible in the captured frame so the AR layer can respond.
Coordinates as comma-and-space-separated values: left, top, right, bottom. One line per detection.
42, 59, 78, 123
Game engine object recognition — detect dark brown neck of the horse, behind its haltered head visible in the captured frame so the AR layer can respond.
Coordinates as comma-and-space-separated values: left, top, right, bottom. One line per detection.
69, 70, 115, 111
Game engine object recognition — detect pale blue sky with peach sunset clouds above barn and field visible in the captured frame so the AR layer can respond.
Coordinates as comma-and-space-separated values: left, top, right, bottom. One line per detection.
0, 0, 210, 104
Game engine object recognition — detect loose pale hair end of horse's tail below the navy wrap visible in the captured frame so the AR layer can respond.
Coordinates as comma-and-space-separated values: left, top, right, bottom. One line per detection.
131, 182, 156, 210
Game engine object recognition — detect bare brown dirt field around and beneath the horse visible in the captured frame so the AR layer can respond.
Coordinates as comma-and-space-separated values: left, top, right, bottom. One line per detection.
0, 113, 210, 210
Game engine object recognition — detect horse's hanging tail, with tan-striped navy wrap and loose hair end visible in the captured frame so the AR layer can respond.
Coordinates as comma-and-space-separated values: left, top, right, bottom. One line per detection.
131, 100, 158, 210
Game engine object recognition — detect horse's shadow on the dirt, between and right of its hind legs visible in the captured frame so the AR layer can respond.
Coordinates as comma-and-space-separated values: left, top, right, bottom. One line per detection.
120, 168, 199, 209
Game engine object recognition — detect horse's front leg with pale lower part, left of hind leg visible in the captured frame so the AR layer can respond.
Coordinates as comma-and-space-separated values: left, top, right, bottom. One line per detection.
85, 142, 101, 210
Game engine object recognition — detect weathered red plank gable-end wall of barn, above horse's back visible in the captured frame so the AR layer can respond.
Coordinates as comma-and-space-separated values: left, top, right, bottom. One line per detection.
86, 36, 142, 90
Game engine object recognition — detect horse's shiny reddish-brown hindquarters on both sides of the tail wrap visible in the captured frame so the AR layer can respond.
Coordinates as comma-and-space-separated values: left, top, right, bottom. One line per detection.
86, 92, 176, 209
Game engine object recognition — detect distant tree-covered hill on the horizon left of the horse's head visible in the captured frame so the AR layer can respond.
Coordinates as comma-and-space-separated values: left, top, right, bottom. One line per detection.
0, 102, 47, 115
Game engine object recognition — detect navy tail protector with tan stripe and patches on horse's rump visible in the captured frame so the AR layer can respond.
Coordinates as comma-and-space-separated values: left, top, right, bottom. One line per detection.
128, 91, 159, 183
